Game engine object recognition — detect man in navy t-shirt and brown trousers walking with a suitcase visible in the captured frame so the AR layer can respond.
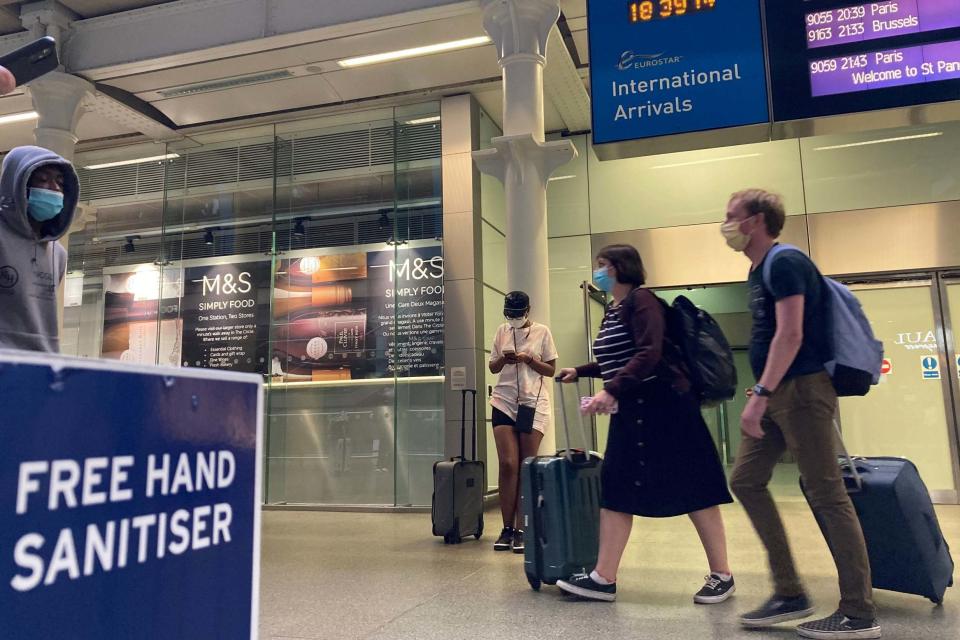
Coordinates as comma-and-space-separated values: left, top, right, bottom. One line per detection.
721, 189, 880, 640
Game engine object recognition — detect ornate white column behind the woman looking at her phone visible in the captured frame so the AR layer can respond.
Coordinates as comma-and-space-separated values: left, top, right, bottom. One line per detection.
473, 0, 577, 451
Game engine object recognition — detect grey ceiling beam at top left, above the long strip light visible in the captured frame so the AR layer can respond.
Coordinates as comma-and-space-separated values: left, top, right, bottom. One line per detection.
50, 0, 479, 80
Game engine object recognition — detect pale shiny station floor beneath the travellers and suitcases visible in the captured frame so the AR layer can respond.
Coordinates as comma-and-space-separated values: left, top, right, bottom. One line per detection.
260, 497, 960, 640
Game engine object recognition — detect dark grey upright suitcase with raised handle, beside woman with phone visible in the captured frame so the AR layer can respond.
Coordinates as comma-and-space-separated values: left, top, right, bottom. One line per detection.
432, 389, 486, 544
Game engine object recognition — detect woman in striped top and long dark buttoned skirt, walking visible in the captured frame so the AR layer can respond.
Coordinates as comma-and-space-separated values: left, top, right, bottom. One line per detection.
557, 245, 734, 604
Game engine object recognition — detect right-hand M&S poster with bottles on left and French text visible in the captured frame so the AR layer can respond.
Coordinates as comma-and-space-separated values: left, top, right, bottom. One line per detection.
272, 247, 443, 382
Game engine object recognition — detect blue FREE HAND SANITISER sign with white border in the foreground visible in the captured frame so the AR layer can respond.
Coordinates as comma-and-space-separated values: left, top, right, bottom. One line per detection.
0, 352, 263, 640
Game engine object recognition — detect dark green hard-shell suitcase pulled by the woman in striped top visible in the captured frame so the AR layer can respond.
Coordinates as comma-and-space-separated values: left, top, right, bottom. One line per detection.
520, 383, 601, 590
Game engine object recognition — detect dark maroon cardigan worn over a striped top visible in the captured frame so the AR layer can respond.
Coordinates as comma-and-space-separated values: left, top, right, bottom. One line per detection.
577, 287, 690, 399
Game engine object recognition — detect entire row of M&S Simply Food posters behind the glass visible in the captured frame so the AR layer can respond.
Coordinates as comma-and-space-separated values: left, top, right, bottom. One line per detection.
102, 246, 444, 382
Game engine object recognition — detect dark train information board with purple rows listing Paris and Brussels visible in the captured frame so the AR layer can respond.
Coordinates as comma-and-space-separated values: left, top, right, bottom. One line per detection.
766, 0, 960, 122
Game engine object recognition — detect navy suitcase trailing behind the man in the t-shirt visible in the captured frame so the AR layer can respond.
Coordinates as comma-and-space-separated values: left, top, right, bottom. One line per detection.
801, 428, 954, 604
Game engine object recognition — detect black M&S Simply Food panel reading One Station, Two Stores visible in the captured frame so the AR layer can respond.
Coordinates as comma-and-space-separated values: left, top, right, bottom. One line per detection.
181, 261, 270, 373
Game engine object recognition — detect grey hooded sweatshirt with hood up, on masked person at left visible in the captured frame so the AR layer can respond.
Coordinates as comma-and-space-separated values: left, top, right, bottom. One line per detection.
0, 147, 80, 353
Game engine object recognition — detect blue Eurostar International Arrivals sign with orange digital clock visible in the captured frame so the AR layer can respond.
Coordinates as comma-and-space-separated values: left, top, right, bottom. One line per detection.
587, 0, 769, 144
